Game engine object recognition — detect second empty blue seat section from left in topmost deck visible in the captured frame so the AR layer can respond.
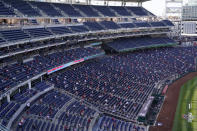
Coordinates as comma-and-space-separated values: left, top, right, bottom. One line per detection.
5, 0, 41, 17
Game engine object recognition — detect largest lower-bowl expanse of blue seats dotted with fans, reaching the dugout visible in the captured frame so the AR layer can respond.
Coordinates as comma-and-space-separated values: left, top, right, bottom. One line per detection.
50, 47, 197, 120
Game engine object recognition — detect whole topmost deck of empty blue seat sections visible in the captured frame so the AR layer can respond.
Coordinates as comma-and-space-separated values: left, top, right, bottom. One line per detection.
0, 0, 153, 17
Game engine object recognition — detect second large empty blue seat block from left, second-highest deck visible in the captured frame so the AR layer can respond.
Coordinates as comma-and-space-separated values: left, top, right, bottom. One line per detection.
25, 28, 52, 37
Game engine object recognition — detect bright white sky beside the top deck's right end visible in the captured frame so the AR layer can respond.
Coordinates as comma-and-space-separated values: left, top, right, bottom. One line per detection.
143, 0, 165, 16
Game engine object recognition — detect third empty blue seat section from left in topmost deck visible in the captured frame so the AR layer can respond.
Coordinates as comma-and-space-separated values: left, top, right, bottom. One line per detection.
31, 2, 62, 17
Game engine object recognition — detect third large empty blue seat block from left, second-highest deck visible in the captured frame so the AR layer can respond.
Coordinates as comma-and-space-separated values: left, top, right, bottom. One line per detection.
49, 26, 72, 34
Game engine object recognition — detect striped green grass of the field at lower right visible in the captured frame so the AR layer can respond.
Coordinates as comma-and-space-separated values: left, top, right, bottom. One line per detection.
173, 77, 197, 131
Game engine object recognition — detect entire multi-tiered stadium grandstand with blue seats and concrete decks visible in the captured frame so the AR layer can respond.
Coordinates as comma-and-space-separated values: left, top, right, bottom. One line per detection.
0, 0, 197, 131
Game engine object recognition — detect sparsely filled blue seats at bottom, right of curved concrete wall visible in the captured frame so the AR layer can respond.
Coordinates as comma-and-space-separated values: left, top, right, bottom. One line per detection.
15, 90, 96, 131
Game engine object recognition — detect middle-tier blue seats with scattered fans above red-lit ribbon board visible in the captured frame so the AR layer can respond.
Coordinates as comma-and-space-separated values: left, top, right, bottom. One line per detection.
0, 47, 101, 93
